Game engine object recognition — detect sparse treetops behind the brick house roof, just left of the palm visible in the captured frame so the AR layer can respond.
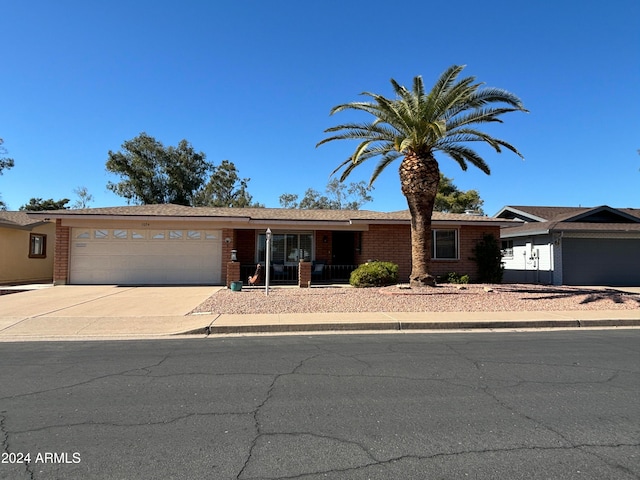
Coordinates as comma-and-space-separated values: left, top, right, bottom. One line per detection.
280, 178, 373, 210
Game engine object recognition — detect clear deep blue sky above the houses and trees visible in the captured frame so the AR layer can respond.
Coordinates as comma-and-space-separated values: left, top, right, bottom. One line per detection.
0, 0, 640, 215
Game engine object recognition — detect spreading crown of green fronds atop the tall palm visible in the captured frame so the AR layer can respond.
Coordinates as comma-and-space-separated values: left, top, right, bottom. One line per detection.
317, 65, 527, 182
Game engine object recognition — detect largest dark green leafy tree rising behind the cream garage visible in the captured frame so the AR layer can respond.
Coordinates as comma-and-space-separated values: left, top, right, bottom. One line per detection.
106, 132, 212, 205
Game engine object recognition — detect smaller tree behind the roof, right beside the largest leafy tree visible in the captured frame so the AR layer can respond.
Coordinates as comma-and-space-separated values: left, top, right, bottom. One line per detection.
193, 160, 264, 208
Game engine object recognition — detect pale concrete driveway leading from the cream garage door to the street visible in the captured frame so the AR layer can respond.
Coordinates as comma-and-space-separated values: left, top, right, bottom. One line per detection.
0, 285, 223, 340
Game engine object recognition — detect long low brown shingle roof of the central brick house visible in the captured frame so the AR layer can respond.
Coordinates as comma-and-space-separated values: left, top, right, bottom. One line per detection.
23, 204, 504, 223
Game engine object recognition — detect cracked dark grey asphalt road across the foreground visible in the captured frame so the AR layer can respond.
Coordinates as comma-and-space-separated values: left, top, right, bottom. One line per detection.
0, 329, 640, 480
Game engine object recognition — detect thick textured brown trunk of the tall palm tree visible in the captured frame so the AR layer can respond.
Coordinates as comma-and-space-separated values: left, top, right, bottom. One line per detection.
400, 154, 440, 287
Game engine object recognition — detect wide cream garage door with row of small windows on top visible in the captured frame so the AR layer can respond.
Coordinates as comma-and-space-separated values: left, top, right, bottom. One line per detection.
69, 228, 222, 285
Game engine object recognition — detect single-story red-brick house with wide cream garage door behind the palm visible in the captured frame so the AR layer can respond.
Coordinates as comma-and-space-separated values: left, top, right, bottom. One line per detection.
30, 205, 508, 284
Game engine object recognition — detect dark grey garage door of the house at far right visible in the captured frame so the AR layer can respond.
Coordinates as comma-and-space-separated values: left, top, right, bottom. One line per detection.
562, 238, 640, 286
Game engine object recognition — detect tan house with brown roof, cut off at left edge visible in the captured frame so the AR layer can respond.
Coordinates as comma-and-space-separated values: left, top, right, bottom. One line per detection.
0, 211, 56, 285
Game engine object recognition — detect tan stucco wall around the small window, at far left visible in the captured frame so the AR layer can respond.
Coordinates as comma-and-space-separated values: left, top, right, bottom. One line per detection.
0, 223, 56, 285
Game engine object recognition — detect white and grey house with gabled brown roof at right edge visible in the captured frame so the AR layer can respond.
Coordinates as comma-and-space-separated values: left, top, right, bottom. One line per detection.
496, 205, 640, 286
